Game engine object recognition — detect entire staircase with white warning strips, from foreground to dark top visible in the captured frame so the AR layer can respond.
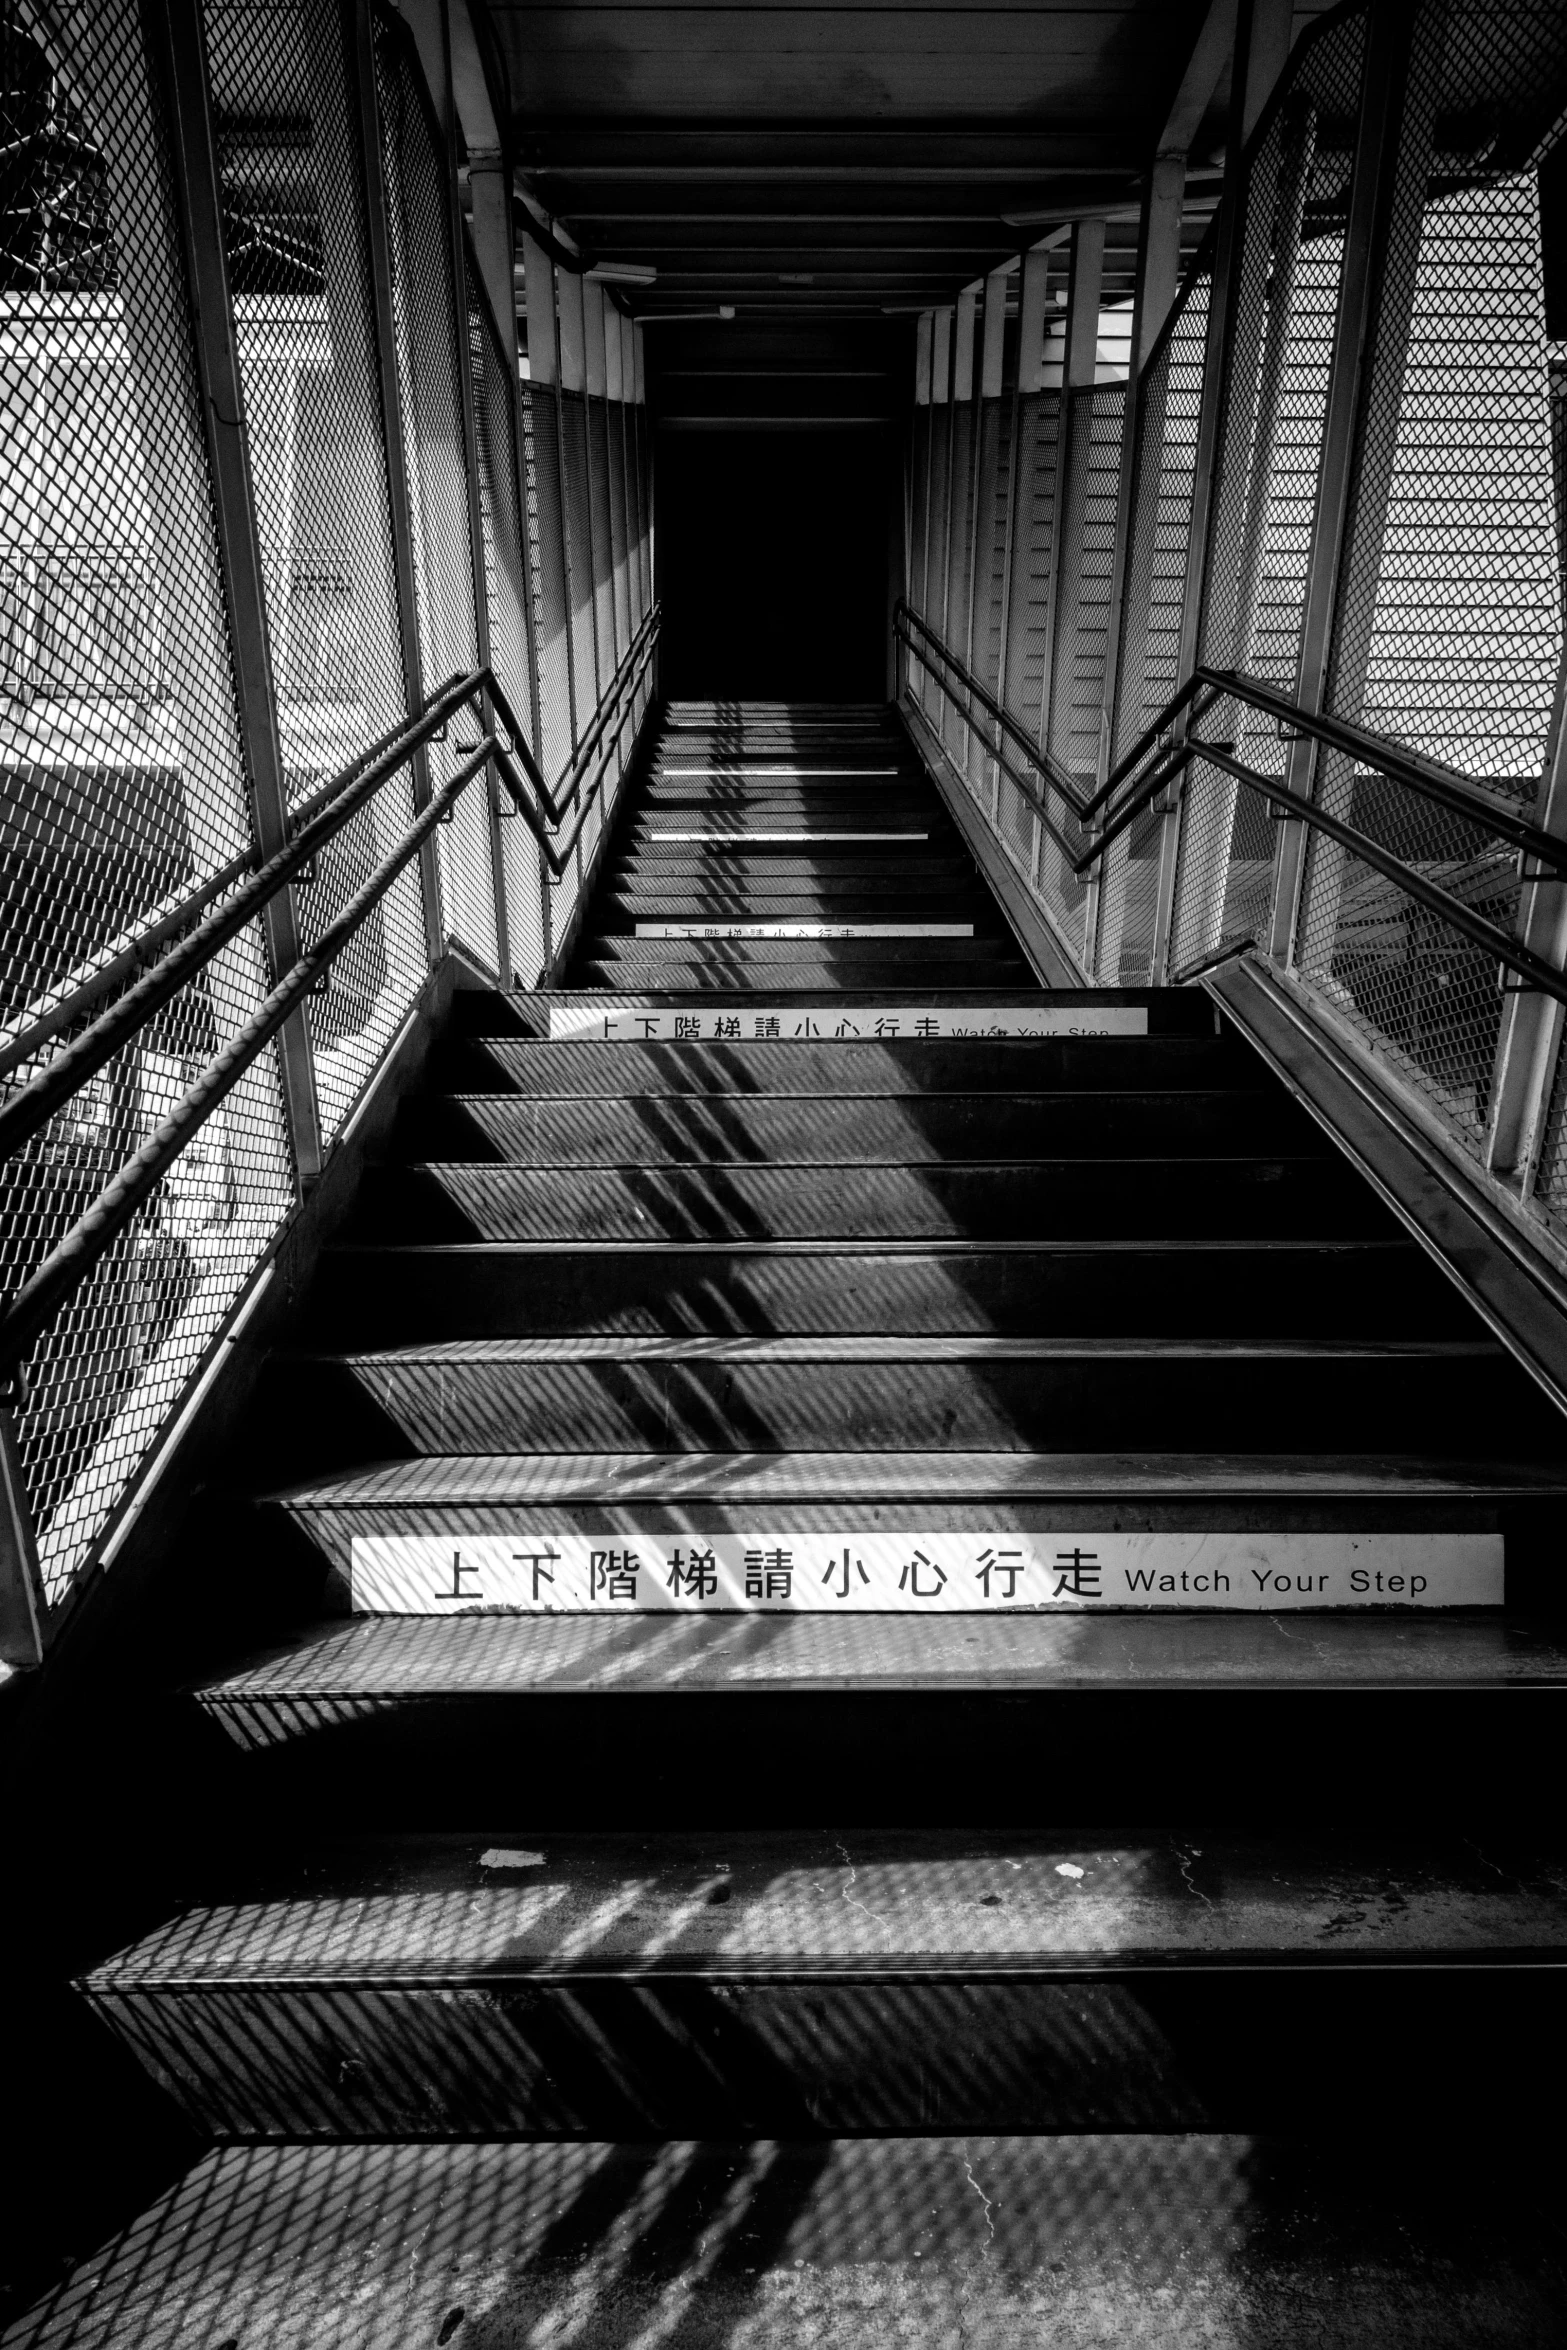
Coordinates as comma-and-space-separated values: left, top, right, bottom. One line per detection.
15, 705, 1567, 2350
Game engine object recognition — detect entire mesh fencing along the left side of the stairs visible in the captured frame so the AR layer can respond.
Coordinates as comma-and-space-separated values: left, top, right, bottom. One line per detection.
0, 0, 651, 1635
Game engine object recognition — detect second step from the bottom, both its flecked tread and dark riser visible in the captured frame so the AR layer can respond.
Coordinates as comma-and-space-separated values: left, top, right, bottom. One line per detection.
82, 1824, 1567, 2139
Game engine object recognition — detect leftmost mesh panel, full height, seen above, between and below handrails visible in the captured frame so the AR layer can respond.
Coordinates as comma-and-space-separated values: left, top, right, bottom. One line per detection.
0, 0, 294, 1603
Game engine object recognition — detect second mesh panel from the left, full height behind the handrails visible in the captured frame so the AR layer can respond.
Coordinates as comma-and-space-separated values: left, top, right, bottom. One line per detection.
204, 0, 425, 1140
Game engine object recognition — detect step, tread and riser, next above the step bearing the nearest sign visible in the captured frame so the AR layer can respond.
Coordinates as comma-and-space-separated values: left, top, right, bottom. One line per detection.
297, 1337, 1555, 1455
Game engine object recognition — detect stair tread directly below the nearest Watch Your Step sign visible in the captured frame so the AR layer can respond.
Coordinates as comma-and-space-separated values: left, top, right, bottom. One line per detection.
197, 1612, 1567, 1708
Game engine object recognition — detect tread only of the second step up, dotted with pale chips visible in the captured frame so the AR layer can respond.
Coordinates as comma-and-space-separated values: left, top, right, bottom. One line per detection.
85, 1824, 1567, 1995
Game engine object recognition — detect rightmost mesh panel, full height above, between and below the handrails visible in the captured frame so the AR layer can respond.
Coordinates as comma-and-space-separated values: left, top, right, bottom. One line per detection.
1294, 7, 1567, 1160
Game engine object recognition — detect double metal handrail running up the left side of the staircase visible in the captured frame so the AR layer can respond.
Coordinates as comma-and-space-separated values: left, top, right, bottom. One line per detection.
0, 606, 660, 1382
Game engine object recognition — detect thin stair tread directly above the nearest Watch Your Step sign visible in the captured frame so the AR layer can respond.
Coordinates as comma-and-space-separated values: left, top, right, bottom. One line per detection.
284, 1452, 1567, 1509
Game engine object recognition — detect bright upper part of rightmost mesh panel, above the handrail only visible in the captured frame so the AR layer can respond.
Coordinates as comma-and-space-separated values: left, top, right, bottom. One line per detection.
1330, 7, 1567, 787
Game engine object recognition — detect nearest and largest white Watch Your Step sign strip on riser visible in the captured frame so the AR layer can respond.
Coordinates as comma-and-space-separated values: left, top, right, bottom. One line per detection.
350, 1528, 1504, 1614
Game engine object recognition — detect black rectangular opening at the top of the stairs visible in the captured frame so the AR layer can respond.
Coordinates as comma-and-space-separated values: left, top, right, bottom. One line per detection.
658, 430, 890, 703
